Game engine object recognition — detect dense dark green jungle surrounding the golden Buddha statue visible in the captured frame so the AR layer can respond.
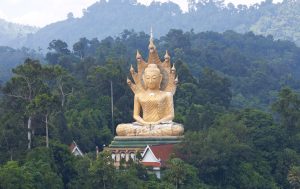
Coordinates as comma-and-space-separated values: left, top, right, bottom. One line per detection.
0, 30, 300, 189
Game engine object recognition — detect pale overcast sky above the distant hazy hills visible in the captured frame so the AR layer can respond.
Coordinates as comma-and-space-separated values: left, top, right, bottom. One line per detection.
0, 0, 282, 27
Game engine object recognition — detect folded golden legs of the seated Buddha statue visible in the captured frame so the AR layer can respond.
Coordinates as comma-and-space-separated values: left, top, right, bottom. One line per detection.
116, 122, 184, 136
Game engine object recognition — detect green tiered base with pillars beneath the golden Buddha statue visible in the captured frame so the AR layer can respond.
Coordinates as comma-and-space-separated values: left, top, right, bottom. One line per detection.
105, 136, 184, 167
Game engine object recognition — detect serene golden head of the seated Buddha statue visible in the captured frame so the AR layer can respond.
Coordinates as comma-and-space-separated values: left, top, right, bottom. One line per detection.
143, 64, 162, 90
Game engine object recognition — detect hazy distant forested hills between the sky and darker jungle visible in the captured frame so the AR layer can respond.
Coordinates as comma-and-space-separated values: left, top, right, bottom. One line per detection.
21, 0, 300, 50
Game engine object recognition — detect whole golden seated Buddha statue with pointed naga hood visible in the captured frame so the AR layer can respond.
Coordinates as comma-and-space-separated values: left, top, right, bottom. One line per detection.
116, 34, 184, 136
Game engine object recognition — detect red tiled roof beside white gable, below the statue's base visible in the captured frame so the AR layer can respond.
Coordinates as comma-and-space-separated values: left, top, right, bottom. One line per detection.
149, 144, 174, 162
